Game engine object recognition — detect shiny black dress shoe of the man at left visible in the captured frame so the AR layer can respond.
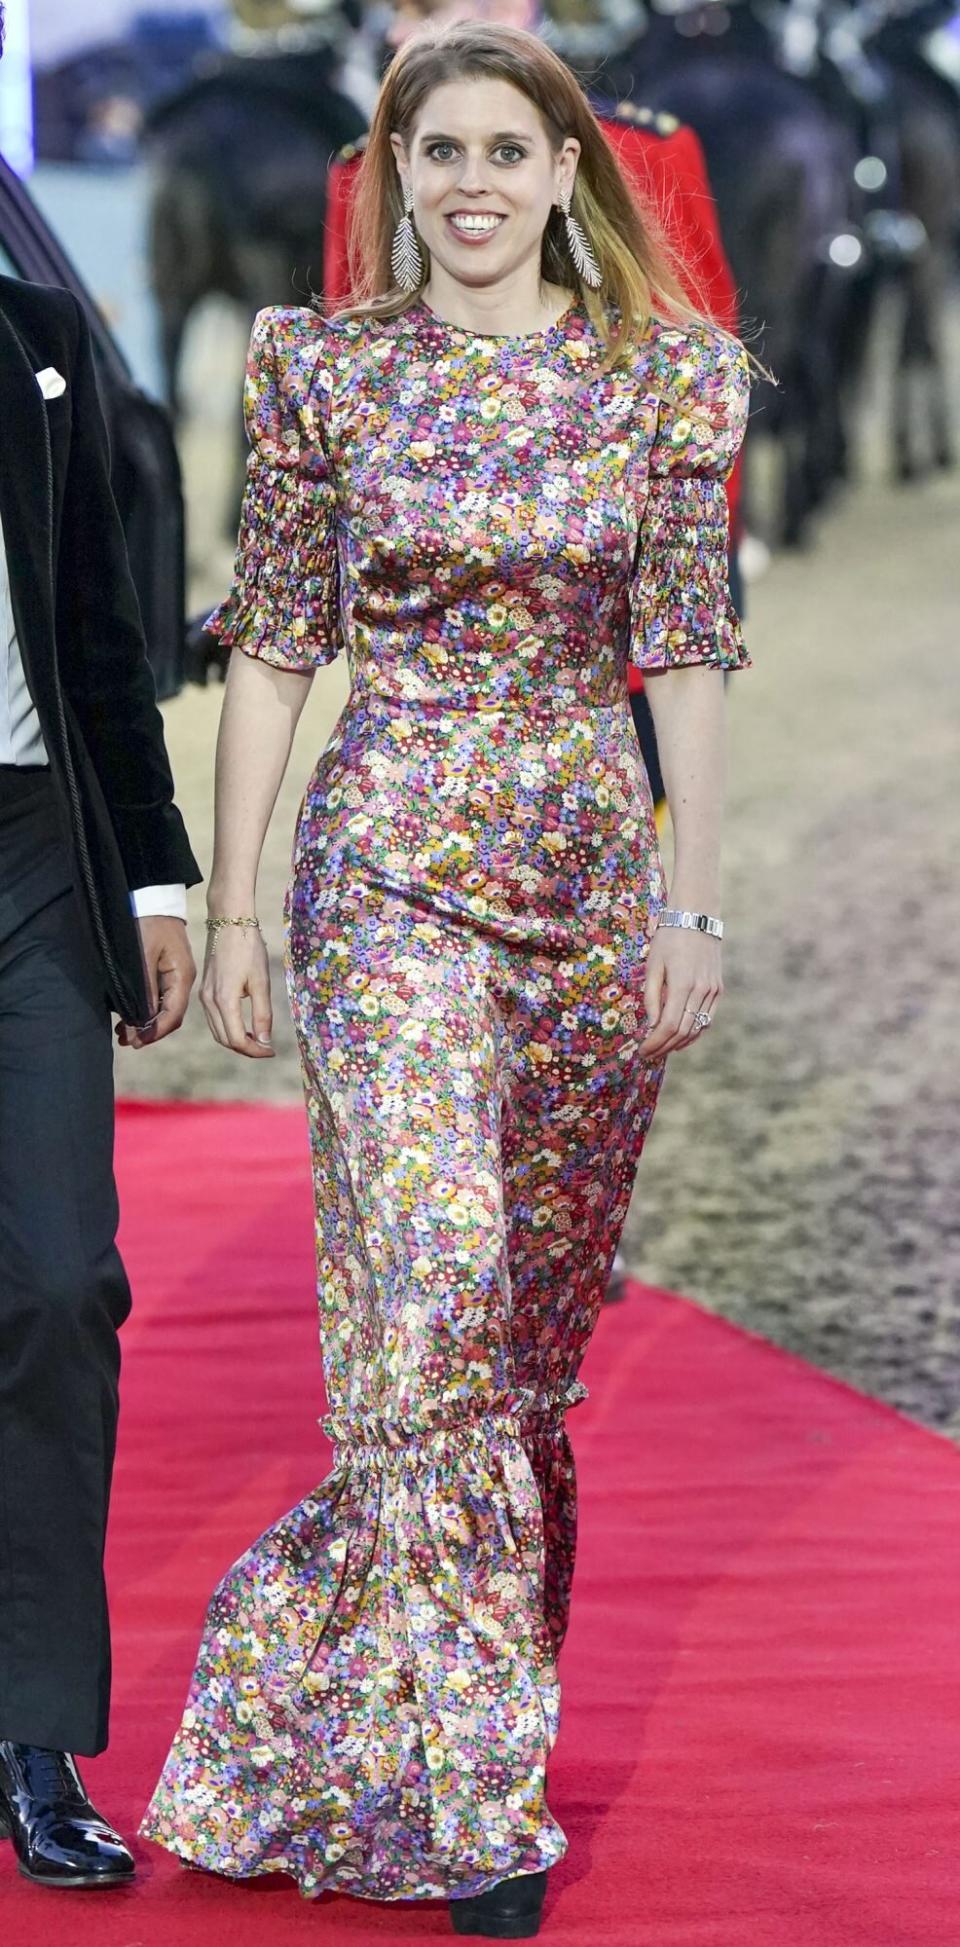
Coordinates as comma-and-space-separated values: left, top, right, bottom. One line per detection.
0, 1739, 134, 1887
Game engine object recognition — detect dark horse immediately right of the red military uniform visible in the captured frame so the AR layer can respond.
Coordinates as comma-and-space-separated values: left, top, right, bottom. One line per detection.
617, 6, 863, 545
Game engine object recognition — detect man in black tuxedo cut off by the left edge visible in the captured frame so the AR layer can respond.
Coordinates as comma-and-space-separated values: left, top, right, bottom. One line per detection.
0, 6, 201, 1887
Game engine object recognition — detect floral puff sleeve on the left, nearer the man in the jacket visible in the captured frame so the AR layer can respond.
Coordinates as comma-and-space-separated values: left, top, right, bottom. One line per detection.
204, 310, 341, 674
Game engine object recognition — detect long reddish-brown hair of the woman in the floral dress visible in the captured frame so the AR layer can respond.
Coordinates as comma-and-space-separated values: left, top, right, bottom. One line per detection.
341, 21, 724, 364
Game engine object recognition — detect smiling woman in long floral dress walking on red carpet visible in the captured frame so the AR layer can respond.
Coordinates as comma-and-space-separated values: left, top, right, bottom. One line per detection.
144, 25, 746, 1939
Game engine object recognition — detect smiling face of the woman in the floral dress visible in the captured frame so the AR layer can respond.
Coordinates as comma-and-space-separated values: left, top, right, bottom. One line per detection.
391, 78, 580, 288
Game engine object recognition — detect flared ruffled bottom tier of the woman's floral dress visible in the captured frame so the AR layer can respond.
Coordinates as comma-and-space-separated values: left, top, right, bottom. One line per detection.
142, 1384, 584, 1900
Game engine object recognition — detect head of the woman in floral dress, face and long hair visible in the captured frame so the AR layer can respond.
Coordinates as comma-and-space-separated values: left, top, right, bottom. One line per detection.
342, 25, 697, 366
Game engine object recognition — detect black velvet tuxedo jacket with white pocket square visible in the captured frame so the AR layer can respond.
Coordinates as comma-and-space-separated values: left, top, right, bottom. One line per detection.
0, 276, 201, 1024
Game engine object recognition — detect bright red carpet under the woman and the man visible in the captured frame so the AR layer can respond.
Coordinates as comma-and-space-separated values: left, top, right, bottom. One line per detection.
0, 1106, 960, 1947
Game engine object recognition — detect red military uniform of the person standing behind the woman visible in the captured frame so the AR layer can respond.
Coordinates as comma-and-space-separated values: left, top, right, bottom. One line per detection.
323, 101, 740, 712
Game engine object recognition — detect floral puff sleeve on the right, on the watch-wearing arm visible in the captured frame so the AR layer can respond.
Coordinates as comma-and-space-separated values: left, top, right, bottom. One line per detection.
629, 329, 750, 670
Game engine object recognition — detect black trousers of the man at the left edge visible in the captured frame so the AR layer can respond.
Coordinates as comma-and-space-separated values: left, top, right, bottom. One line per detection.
0, 769, 130, 1756
